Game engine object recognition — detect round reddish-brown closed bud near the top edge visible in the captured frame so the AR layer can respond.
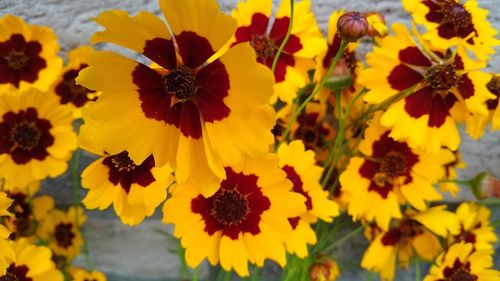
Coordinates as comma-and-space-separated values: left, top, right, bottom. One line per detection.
337, 12, 368, 42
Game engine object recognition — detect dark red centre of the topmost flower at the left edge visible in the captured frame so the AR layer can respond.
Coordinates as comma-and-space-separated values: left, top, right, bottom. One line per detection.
0, 34, 47, 88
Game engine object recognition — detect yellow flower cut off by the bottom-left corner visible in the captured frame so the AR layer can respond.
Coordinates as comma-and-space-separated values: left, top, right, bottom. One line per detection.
0, 239, 64, 281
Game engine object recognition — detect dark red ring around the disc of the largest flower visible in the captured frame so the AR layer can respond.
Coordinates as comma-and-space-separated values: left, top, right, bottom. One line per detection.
132, 31, 230, 139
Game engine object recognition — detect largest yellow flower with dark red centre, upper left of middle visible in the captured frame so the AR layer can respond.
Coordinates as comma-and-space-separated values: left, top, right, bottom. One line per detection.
76, 0, 274, 196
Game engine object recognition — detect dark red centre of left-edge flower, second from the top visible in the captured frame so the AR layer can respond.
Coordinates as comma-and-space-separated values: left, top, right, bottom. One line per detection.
0, 107, 54, 165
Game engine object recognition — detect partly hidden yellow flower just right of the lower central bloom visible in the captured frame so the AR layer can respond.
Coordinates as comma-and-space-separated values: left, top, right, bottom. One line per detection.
278, 140, 339, 257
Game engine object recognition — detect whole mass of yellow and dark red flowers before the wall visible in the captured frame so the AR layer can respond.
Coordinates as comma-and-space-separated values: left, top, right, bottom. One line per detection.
0, 0, 500, 281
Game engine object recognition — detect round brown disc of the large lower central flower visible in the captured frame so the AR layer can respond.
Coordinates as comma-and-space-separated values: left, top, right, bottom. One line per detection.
211, 189, 250, 226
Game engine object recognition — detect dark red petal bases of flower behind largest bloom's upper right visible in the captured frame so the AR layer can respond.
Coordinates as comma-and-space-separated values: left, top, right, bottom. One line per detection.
235, 13, 303, 83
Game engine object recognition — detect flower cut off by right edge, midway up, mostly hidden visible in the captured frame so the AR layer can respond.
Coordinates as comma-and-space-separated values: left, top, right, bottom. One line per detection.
466, 74, 500, 137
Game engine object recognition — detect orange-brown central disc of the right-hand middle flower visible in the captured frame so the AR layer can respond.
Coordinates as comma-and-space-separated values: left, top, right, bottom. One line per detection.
373, 151, 408, 187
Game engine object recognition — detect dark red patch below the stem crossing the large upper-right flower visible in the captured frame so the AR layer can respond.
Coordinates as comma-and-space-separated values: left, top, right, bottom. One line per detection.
404, 87, 457, 128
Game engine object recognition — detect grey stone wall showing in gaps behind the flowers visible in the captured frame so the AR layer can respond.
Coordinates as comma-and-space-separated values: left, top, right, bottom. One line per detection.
0, 0, 500, 281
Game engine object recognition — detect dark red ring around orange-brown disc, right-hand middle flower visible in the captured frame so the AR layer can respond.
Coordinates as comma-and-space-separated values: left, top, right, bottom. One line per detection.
359, 132, 419, 199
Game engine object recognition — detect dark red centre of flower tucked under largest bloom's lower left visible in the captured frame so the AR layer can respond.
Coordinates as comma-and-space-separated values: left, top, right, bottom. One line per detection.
102, 151, 155, 193
